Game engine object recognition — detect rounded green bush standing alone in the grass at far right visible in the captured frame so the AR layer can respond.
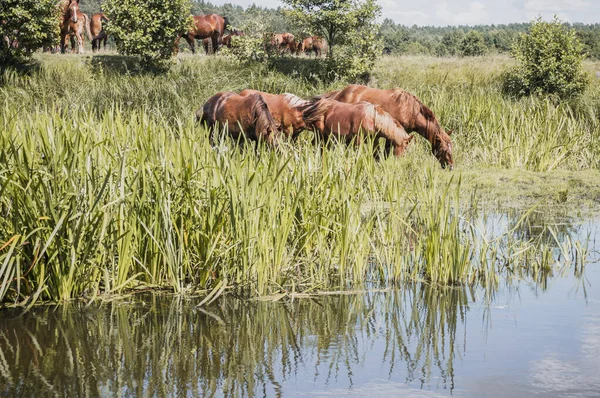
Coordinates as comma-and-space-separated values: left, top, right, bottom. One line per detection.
503, 18, 588, 98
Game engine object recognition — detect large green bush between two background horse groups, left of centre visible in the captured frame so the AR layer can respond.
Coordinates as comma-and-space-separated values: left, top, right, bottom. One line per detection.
103, 0, 191, 67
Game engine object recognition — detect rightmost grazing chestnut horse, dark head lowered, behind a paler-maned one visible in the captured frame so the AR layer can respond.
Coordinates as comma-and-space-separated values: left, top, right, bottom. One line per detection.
323, 85, 454, 170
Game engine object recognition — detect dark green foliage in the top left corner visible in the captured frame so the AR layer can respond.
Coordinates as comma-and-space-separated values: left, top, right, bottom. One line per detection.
0, 0, 59, 61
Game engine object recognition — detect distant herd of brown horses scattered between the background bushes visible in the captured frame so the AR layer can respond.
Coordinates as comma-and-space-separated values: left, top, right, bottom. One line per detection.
44, 0, 327, 56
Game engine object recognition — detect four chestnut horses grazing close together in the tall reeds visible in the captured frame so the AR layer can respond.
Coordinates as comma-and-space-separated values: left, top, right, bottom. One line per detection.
196, 84, 454, 169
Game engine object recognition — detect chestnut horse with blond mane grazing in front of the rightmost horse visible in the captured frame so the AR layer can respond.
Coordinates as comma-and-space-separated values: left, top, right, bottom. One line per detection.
304, 98, 413, 156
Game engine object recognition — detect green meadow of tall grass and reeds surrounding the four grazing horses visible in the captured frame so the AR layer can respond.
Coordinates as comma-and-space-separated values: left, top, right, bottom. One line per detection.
0, 55, 600, 305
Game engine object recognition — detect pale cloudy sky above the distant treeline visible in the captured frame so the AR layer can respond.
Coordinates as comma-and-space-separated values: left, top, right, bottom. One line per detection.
211, 0, 600, 26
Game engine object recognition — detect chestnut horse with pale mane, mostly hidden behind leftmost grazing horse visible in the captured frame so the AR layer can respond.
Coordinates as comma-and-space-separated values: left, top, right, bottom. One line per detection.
240, 90, 311, 140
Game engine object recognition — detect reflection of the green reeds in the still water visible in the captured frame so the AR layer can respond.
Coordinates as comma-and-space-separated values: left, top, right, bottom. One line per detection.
0, 285, 468, 396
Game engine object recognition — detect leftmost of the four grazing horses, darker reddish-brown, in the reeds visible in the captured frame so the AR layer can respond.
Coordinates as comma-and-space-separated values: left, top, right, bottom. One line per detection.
196, 92, 279, 147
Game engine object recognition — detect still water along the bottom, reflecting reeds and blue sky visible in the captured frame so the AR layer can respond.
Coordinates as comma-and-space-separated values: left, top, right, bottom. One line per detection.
0, 216, 600, 397
